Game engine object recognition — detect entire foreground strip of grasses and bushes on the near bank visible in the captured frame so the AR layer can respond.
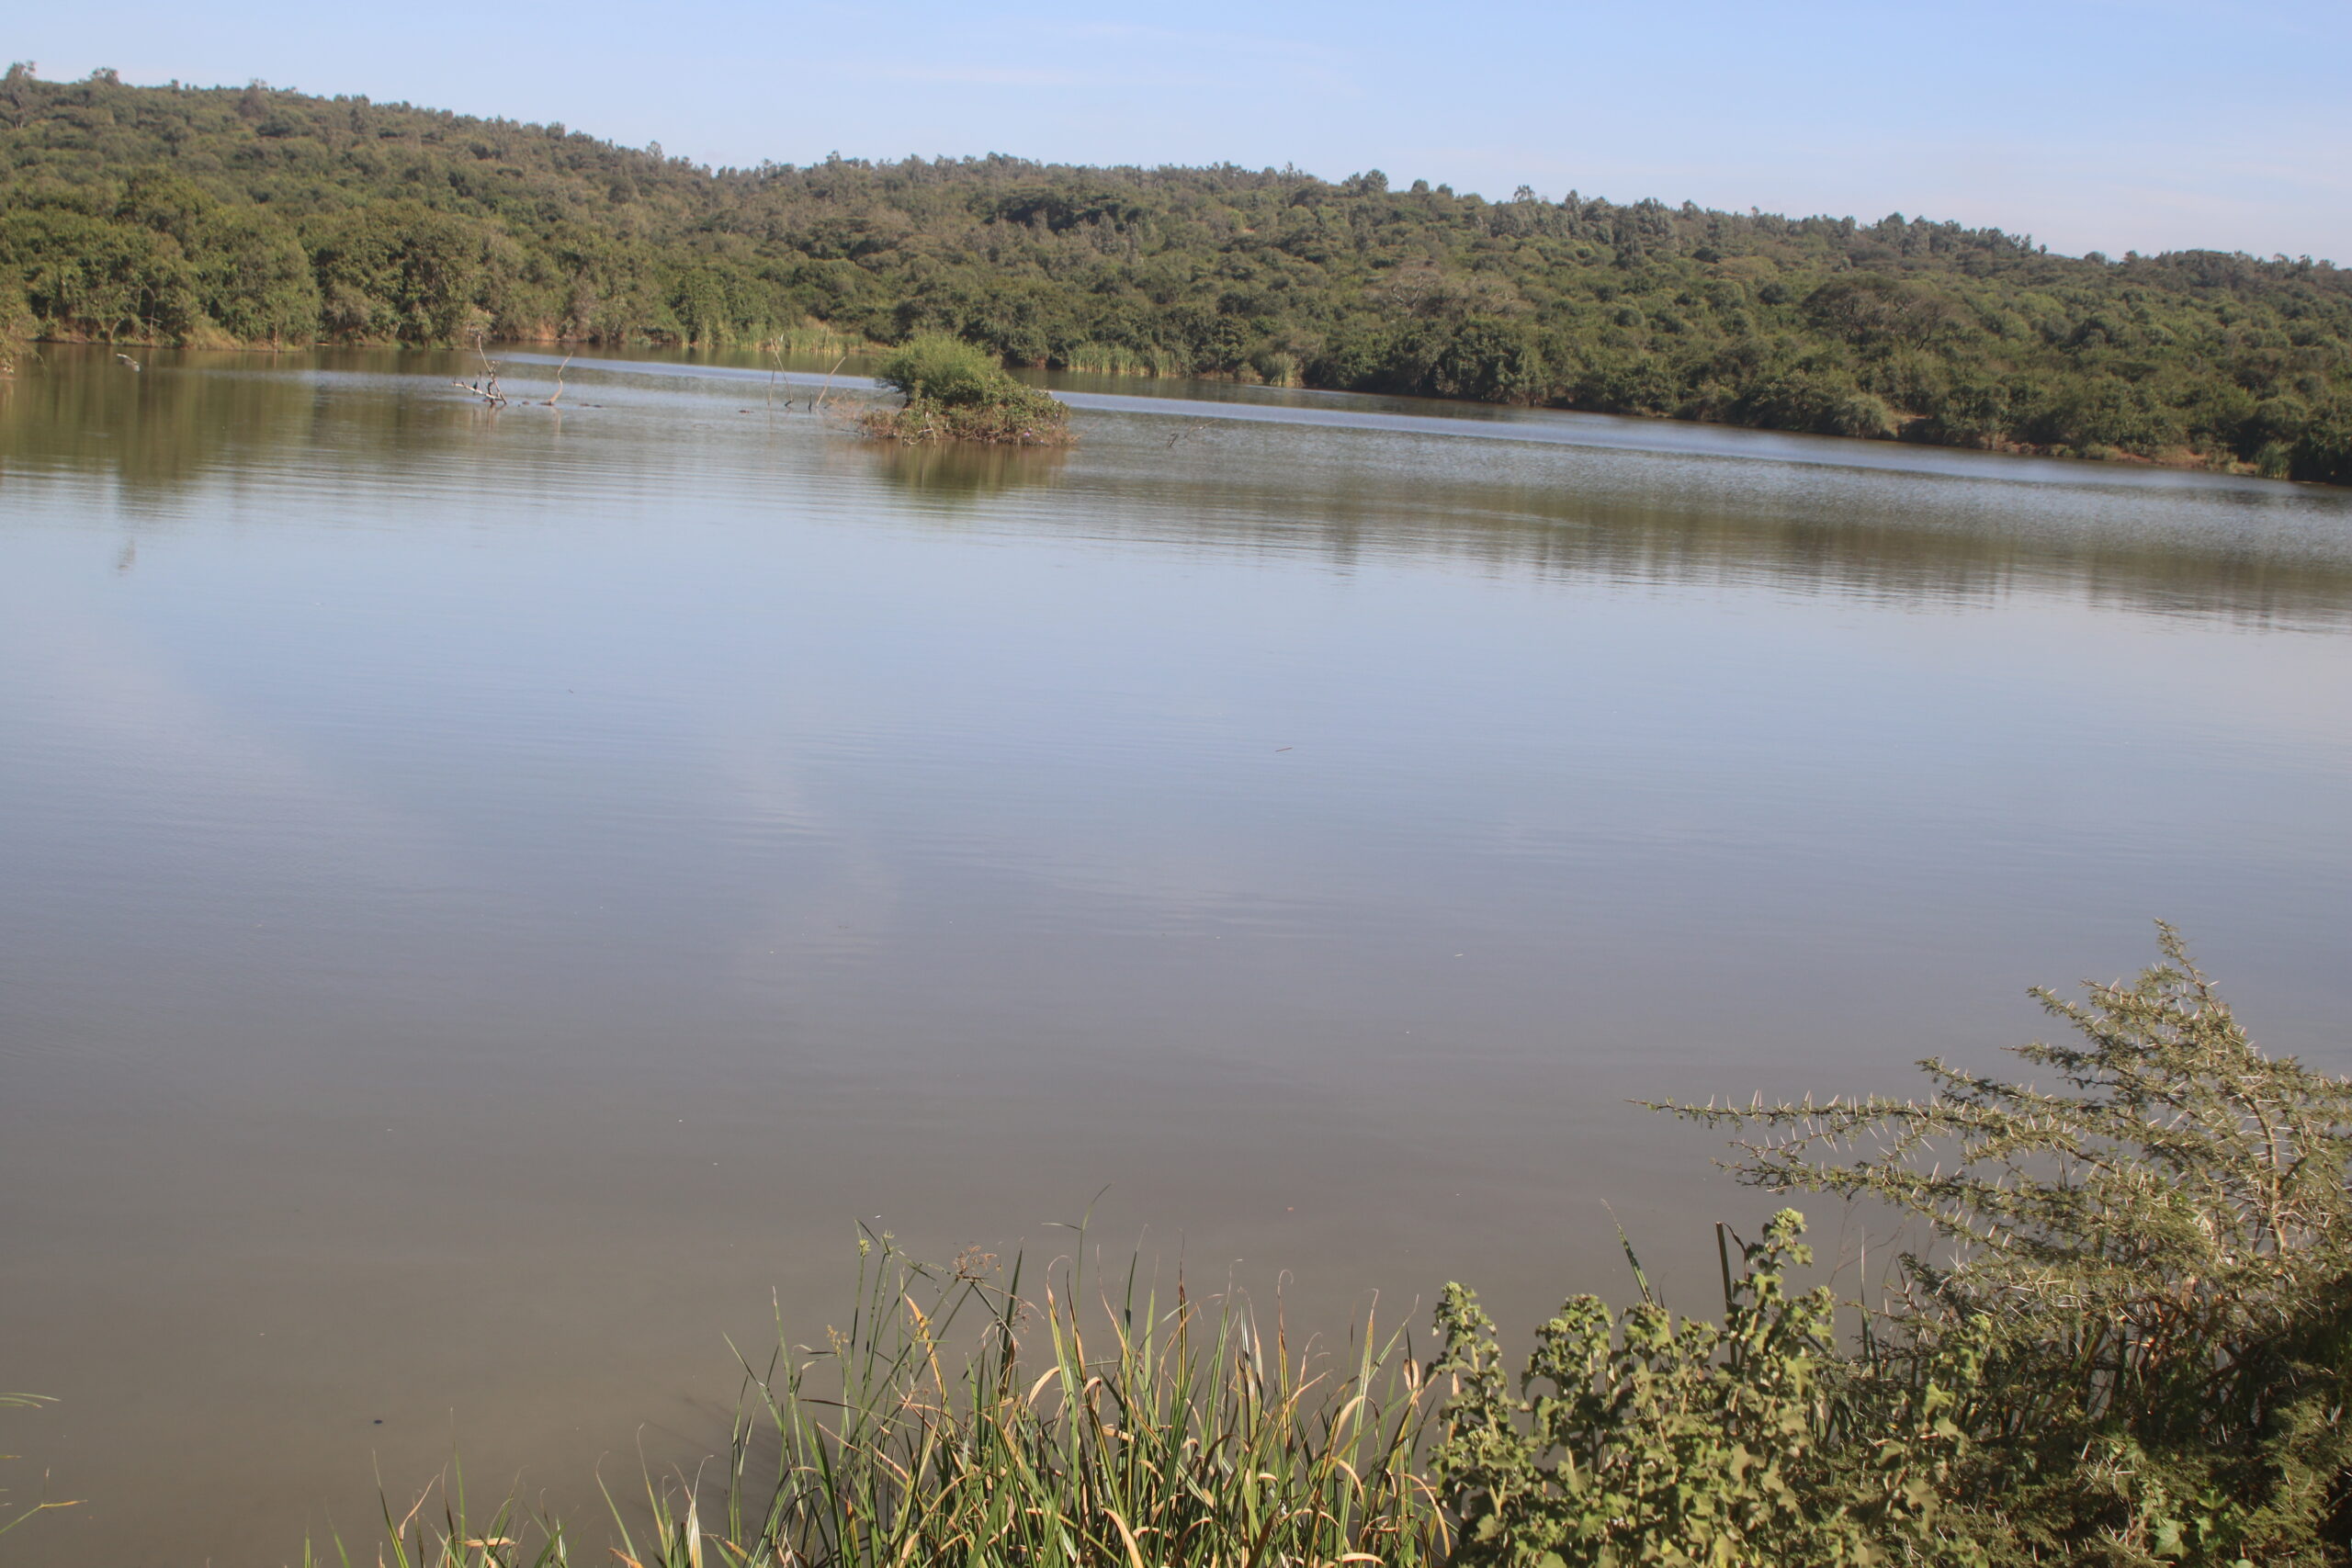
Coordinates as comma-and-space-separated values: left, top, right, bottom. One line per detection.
331, 929, 2352, 1568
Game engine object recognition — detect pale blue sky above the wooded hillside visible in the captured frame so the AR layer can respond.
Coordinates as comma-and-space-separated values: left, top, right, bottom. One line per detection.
7, 0, 2352, 264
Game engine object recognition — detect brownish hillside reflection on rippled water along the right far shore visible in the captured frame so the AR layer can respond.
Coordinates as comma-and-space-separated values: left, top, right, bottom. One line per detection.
1053, 430, 2352, 626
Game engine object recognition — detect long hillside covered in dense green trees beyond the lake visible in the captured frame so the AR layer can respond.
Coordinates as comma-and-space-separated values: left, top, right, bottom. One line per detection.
0, 66, 2352, 482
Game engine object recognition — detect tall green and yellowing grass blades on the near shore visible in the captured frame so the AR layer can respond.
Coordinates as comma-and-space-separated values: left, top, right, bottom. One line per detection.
362, 1235, 1449, 1568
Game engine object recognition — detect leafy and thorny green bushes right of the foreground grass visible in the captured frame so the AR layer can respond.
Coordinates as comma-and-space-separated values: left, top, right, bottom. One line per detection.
1435, 929, 2352, 1568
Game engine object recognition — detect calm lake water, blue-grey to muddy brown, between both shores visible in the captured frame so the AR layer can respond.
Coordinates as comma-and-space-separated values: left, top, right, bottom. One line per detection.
0, 353, 2352, 1565
